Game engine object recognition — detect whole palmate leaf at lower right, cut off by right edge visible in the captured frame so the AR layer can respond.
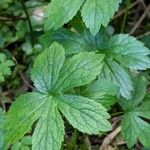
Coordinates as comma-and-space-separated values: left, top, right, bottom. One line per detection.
119, 77, 150, 148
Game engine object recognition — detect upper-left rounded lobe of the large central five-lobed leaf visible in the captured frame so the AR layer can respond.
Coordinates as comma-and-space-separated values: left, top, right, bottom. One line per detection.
31, 43, 65, 93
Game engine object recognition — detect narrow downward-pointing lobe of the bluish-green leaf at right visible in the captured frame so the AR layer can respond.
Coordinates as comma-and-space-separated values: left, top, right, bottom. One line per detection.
100, 60, 133, 99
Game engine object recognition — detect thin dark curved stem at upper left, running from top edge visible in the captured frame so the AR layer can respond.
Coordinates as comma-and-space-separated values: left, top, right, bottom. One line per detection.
20, 0, 34, 48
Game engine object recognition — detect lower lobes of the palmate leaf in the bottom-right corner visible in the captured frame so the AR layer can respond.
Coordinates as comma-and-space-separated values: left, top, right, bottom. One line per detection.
121, 111, 150, 148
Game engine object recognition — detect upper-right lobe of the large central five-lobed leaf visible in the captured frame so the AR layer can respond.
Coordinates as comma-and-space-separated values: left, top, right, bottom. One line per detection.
54, 52, 104, 91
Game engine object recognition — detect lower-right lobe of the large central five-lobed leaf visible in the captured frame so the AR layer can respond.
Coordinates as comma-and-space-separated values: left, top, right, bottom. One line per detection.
56, 94, 111, 134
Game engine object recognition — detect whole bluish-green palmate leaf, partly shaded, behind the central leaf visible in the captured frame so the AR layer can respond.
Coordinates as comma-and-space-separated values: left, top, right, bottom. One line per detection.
40, 28, 150, 99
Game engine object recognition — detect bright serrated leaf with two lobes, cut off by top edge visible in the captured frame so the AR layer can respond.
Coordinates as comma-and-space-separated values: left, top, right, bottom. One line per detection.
45, 0, 121, 35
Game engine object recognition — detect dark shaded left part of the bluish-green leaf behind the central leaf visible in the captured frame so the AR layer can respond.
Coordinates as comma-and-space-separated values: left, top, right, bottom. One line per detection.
39, 26, 110, 55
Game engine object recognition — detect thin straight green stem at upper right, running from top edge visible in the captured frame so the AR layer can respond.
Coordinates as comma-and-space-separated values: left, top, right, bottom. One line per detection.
120, 0, 130, 33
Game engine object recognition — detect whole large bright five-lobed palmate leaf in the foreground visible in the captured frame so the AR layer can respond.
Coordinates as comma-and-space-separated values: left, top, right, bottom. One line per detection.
6, 43, 111, 150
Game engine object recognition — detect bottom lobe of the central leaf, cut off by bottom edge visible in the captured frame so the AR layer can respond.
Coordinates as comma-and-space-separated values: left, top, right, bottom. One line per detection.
32, 97, 65, 150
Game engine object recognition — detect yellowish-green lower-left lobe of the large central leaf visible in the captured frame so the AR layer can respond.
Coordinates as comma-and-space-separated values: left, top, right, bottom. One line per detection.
6, 92, 47, 144
